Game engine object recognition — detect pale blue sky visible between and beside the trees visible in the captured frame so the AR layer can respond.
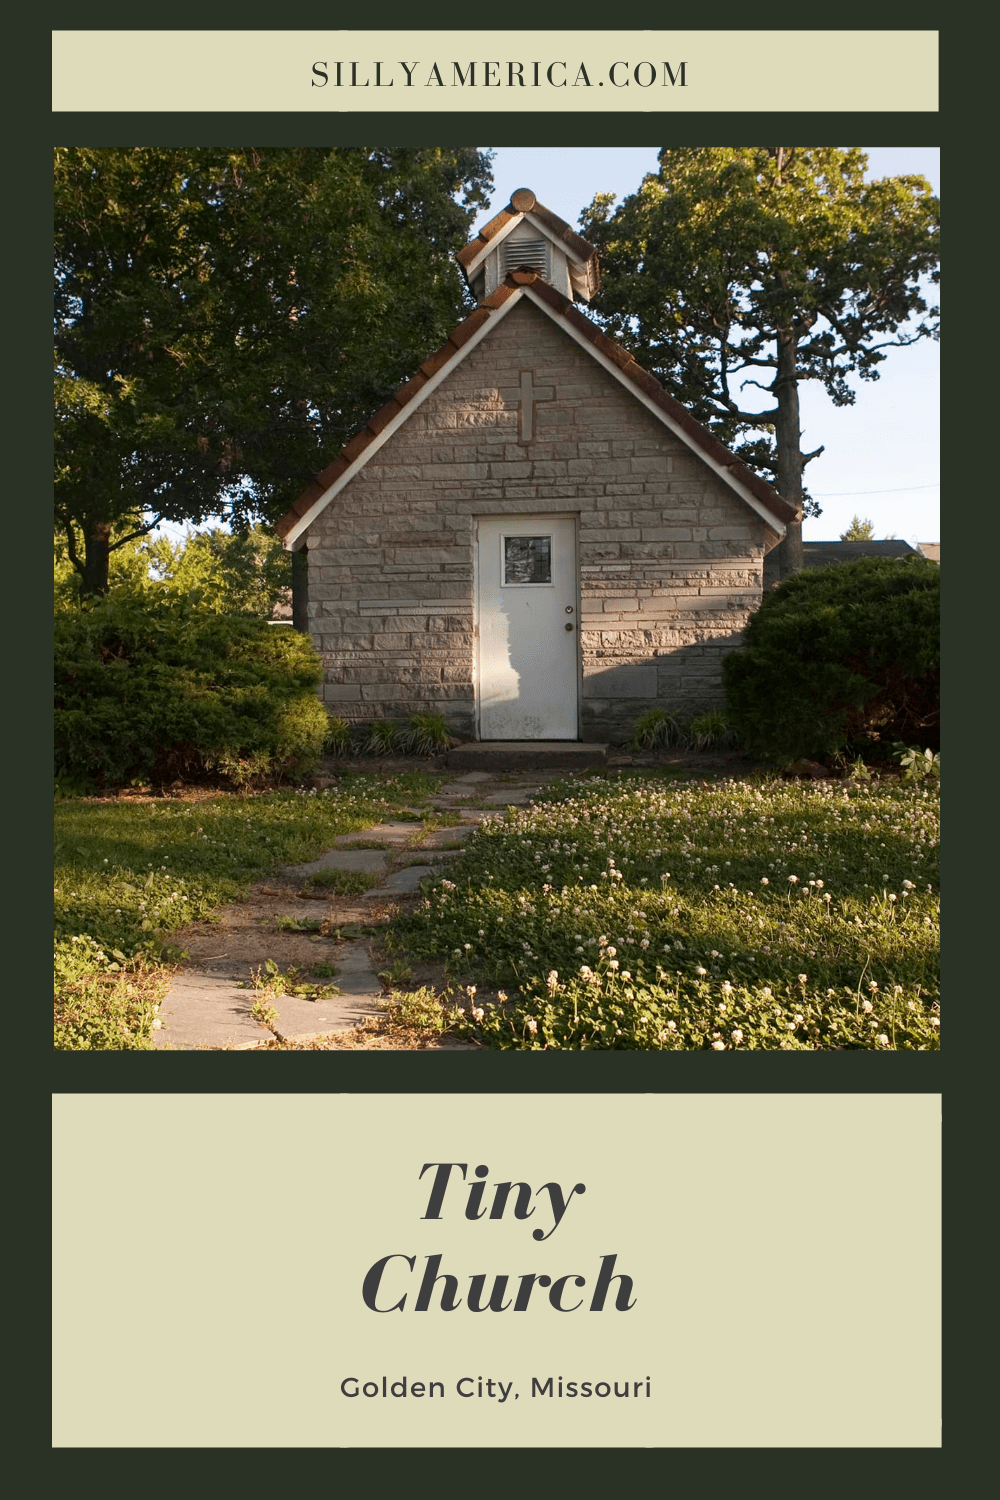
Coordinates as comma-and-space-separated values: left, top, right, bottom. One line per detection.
475, 146, 940, 546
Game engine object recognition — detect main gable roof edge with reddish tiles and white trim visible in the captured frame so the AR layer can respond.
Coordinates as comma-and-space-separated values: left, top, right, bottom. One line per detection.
274, 273, 795, 548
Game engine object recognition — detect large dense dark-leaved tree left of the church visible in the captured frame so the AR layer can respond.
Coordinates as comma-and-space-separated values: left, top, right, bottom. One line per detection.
55, 147, 490, 594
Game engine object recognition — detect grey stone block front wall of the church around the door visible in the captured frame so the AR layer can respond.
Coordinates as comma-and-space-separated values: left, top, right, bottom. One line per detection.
307, 300, 765, 740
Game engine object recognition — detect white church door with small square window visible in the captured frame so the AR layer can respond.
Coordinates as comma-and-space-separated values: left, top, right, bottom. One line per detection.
477, 516, 580, 740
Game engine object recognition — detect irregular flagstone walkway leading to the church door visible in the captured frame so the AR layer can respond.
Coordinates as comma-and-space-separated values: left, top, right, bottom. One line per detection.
154, 770, 565, 1052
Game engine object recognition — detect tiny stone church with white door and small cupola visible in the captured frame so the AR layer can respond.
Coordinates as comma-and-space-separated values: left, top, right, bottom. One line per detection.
277, 188, 795, 741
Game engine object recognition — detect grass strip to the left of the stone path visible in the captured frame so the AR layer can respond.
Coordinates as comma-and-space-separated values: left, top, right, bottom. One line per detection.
55, 771, 439, 1050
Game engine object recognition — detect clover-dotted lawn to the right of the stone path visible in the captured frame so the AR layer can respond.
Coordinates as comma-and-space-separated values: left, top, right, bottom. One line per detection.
394, 773, 940, 1052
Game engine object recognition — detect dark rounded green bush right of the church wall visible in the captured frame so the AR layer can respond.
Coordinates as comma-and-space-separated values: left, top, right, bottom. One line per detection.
726, 558, 940, 761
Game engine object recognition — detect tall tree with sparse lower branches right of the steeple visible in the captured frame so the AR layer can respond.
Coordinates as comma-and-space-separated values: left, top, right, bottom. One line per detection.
580, 146, 939, 576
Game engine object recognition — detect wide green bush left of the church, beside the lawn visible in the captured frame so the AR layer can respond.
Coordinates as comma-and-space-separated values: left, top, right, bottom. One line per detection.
55, 588, 328, 786
